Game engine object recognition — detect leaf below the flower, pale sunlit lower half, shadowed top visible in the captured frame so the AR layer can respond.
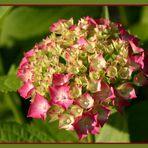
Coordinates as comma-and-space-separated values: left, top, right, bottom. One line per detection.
96, 112, 130, 142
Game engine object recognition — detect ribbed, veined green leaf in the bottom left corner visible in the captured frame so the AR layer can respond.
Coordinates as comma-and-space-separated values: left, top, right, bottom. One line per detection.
0, 122, 54, 142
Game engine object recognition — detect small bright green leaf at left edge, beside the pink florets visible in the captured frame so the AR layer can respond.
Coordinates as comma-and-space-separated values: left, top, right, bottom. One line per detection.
0, 75, 21, 93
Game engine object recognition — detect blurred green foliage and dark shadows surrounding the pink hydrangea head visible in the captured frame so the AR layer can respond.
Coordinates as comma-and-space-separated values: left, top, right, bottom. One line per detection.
0, 6, 148, 142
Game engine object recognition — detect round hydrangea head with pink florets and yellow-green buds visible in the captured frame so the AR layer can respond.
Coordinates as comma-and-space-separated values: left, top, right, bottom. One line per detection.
17, 17, 148, 139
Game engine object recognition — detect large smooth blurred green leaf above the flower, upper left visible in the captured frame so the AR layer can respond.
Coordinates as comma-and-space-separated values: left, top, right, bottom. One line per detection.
0, 6, 98, 46
